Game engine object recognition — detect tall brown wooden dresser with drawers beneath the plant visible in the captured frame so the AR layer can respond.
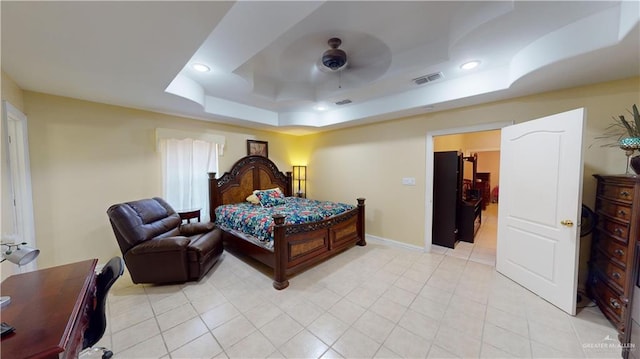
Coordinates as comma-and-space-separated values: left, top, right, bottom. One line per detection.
588, 175, 640, 357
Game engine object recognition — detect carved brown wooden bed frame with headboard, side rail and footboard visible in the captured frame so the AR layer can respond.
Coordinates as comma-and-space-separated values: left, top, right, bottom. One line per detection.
209, 156, 366, 290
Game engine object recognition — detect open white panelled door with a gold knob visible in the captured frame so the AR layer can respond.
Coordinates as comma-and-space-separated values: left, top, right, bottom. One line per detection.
496, 109, 585, 315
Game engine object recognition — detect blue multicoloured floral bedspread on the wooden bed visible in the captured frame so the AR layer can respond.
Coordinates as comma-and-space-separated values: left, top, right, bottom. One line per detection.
215, 197, 355, 248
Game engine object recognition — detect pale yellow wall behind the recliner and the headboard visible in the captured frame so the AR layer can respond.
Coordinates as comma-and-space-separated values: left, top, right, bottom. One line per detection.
24, 92, 299, 267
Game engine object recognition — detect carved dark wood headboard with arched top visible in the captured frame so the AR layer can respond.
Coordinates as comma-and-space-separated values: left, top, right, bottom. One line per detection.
209, 156, 293, 221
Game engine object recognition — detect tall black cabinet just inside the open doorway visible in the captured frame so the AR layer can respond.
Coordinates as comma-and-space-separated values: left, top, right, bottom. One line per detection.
431, 151, 462, 248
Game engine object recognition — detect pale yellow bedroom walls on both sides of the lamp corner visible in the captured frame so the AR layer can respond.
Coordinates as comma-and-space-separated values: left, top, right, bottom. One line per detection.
3, 74, 640, 292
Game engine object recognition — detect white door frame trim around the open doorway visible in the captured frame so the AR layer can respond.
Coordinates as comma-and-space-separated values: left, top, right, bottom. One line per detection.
424, 121, 514, 252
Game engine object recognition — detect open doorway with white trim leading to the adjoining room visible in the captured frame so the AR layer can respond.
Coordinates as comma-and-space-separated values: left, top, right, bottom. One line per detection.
425, 123, 511, 266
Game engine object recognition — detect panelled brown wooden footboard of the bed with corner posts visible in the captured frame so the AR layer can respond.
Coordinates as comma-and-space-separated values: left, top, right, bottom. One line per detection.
273, 198, 367, 290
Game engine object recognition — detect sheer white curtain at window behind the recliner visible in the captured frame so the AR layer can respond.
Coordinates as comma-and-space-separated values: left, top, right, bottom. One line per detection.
159, 138, 220, 222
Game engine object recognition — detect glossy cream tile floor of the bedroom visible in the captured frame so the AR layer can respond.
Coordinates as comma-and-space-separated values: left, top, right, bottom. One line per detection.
99, 204, 619, 358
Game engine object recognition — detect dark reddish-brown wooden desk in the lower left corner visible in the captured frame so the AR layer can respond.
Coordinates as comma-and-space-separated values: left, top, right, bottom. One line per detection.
0, 259, 98, 359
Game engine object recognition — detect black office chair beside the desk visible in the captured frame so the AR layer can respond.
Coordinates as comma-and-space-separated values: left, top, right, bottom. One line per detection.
82, 257, 124, 359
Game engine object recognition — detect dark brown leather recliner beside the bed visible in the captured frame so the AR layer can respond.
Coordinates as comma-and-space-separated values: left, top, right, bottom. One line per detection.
107, 197, 222, 283
